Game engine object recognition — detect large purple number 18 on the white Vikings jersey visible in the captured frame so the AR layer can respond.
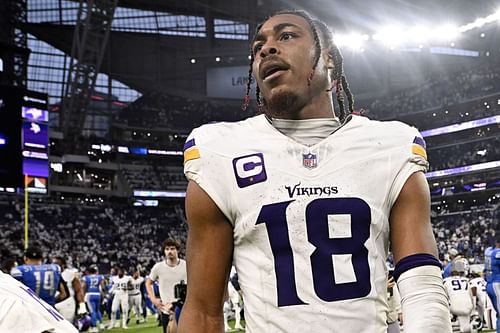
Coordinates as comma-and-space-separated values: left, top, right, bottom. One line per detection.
256, 198, 371, 306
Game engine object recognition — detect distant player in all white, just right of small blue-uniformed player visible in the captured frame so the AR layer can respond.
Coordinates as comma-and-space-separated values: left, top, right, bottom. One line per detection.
109, 267, 132, 329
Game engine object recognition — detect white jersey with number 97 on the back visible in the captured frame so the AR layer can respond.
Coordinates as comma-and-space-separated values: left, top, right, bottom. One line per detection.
443, 276, 474, 316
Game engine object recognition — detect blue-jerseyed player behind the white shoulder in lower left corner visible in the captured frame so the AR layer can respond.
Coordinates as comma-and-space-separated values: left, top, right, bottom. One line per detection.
11, 246, 69, 306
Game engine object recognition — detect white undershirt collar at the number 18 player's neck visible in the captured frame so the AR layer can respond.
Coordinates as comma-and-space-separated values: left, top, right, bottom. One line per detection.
270, 117, 341, 146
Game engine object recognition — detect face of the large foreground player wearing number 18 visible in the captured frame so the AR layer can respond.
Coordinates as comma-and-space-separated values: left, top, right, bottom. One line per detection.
252, 14, 326, 116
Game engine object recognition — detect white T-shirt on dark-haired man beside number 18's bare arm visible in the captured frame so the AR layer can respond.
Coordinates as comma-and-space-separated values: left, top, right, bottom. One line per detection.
149, 259, 187, 304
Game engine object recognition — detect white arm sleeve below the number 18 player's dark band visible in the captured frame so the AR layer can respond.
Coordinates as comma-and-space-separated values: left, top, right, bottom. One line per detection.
397, 265, 452, 333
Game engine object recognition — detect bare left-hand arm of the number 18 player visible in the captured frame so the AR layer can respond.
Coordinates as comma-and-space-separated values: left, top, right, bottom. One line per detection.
178, 181, 233, 333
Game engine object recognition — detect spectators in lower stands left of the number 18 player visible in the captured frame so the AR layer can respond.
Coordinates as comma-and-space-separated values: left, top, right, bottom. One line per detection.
0, 203, 186, 272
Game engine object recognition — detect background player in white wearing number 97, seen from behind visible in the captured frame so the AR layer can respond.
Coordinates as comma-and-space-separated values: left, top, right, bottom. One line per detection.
444, 258, 476, 333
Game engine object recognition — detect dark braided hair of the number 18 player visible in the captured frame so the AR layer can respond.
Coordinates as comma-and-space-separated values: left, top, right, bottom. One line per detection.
243, 10, 354, 120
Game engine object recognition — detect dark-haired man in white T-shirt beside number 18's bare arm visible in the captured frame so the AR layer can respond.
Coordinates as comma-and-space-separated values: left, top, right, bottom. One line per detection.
146, 239, 188, 333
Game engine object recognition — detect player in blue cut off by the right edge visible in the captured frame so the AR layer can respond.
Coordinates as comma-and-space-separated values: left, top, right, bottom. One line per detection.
484, 237, 500, 333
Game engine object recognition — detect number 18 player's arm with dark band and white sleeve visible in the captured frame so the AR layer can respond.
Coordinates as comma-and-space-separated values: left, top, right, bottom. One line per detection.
390, 172, 451, 333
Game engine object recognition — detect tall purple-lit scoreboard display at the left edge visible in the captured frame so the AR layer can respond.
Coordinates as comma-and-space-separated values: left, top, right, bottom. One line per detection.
0, 86, 49, 193
